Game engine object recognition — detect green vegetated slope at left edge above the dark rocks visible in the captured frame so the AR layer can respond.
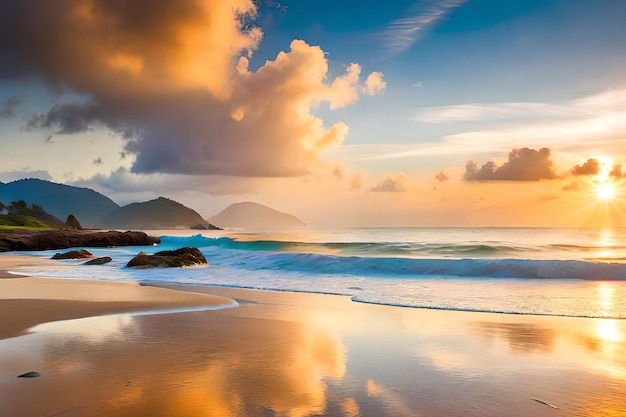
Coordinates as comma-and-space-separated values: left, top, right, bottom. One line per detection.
0, 200, 65, 229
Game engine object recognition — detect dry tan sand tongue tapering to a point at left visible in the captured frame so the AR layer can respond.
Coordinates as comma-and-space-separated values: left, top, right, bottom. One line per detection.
0, 254, 236, 340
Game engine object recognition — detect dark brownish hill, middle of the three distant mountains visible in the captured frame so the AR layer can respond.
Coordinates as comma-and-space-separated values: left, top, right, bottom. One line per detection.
96, 197, 216, 230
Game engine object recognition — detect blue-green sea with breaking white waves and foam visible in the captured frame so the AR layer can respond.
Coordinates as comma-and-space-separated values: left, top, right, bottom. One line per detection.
7, 227, 626, 319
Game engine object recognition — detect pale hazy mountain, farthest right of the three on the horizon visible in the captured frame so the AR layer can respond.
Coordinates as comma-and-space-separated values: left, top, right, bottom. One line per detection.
208, 202, 306, 229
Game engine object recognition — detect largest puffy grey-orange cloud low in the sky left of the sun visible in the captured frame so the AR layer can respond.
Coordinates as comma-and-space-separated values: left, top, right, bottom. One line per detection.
463, 148, 558, 181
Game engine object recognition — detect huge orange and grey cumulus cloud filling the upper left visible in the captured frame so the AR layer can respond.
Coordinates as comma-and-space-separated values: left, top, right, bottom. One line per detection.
0, 0, 385, 176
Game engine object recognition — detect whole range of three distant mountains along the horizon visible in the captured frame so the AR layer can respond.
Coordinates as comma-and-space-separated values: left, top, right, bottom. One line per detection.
0, 178, 305, 230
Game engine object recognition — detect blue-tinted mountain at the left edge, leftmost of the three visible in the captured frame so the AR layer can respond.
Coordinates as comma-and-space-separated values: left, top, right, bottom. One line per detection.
0, 178, 119, 227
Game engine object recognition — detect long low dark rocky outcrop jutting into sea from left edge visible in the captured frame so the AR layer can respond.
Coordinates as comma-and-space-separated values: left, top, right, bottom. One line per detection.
0, 229, 160, 252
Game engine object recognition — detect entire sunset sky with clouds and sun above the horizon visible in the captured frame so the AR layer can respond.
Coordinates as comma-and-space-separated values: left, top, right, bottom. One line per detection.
0, 0, 626, 227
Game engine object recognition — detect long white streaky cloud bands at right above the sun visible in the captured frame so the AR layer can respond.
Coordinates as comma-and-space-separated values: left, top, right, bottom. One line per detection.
326, 89, 626, 161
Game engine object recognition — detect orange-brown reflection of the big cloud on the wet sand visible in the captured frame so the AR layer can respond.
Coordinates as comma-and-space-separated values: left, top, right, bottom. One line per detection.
0, 312, 345, 417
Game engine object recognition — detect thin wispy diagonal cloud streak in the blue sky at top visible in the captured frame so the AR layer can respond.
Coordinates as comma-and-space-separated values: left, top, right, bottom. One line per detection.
380, 0, 467, 55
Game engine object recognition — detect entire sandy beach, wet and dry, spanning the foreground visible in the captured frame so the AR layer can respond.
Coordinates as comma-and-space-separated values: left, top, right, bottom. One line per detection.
0, 252, 626, 417
